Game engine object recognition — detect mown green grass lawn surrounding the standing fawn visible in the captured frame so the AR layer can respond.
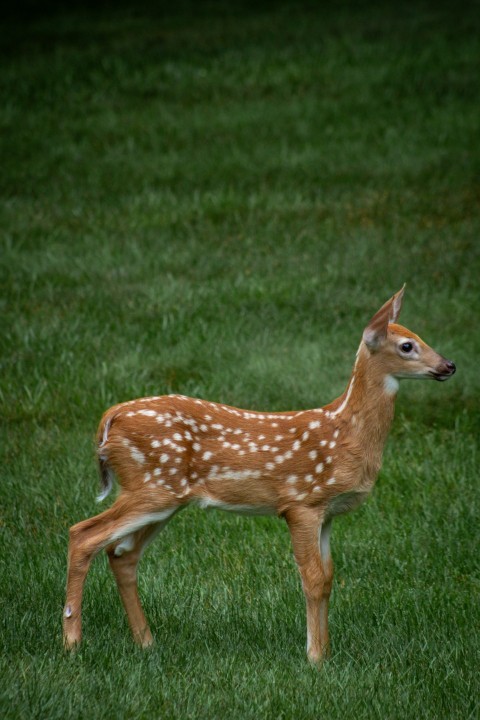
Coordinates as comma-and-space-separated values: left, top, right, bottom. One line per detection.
0, 0, 480, 720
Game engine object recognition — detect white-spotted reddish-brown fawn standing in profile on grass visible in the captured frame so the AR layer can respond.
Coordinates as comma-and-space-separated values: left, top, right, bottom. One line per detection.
63, 288, 455, 662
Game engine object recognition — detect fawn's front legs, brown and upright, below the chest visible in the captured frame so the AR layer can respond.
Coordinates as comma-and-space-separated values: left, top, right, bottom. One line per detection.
286, 508, 332, 664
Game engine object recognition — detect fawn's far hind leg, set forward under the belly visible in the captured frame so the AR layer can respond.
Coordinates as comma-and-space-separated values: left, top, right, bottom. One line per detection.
107, 513, 177, 647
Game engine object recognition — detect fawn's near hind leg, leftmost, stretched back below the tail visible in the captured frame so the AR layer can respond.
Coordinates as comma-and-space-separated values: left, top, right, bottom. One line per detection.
63, 493, 178, 649
